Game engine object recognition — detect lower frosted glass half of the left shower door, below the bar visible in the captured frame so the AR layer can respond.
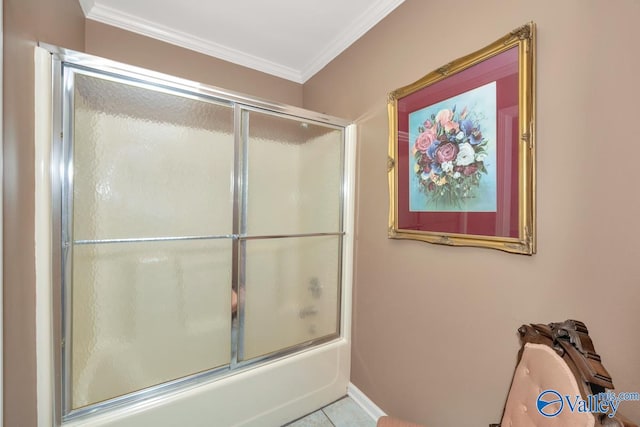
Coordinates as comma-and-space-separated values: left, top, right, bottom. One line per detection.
71, 239, 231, 408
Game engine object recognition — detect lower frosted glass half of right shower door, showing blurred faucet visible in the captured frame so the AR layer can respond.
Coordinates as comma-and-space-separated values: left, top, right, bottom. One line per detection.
244, 236, 341, 359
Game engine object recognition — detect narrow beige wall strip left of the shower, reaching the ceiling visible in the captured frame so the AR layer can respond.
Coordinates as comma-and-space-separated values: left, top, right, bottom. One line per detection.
3, 0, 84, 426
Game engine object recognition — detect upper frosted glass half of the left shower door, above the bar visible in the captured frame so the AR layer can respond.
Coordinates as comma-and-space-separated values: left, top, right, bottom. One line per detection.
73, 75, 234, 240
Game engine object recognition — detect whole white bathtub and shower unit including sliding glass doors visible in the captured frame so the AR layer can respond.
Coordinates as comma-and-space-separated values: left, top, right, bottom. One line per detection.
36, 46, 355, 426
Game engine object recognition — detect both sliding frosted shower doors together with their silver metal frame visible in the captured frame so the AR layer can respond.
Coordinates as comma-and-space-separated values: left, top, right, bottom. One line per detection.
59, 63, 345, 418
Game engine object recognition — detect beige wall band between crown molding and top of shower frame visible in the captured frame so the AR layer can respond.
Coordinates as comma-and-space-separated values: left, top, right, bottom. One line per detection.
85, 20, 302, 107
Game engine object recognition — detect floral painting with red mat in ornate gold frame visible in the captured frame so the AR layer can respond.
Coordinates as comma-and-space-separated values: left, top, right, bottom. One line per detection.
388, 23, 536, 255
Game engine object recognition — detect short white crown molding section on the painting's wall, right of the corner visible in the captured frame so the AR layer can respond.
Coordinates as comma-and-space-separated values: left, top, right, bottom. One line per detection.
301, 0, 404, 82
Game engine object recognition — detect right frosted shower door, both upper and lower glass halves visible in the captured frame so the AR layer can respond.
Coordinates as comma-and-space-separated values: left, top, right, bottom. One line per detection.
239, 111, 344, 360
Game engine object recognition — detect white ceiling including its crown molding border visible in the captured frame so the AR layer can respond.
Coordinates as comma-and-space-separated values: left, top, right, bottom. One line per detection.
79, 0, 404, 83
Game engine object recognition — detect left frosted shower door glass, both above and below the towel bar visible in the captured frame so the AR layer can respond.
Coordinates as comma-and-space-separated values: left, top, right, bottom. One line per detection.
65, 73, 234, 410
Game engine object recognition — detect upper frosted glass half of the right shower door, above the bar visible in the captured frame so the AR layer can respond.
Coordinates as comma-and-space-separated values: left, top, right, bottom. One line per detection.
246, 113, 343, 235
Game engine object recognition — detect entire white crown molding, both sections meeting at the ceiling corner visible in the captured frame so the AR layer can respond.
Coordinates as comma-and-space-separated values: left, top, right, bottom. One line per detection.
79, 0, 404, 84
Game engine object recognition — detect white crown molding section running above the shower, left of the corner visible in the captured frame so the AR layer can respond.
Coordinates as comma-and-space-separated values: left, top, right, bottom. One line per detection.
81, 0, 304, 83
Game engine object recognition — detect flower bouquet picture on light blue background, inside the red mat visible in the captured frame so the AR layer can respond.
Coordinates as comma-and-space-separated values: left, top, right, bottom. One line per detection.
408, 82, 497, 212
